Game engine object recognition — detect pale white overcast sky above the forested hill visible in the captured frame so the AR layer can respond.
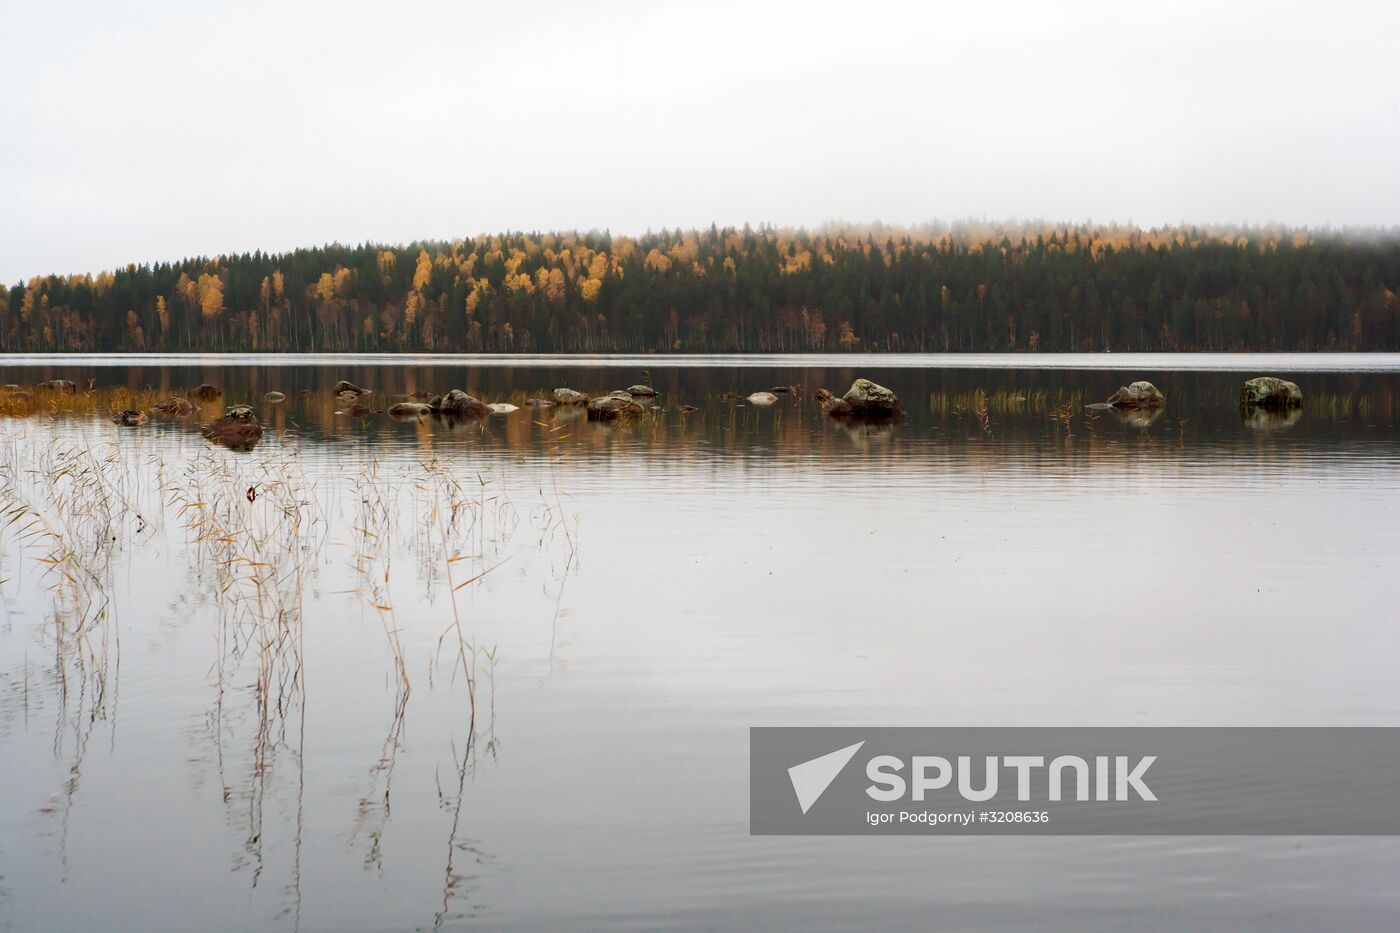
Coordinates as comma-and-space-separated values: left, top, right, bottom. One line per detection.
0, 0, 1400, 283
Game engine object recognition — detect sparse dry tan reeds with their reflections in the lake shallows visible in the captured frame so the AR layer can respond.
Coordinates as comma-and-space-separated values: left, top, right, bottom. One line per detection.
0, 409, 577, 905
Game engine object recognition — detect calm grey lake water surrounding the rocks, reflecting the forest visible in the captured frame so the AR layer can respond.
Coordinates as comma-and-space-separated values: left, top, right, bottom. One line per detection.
0, 356, 1400, 930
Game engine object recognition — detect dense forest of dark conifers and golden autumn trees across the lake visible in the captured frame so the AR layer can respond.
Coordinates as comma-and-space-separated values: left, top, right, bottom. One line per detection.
0, 224, 1400, 353
